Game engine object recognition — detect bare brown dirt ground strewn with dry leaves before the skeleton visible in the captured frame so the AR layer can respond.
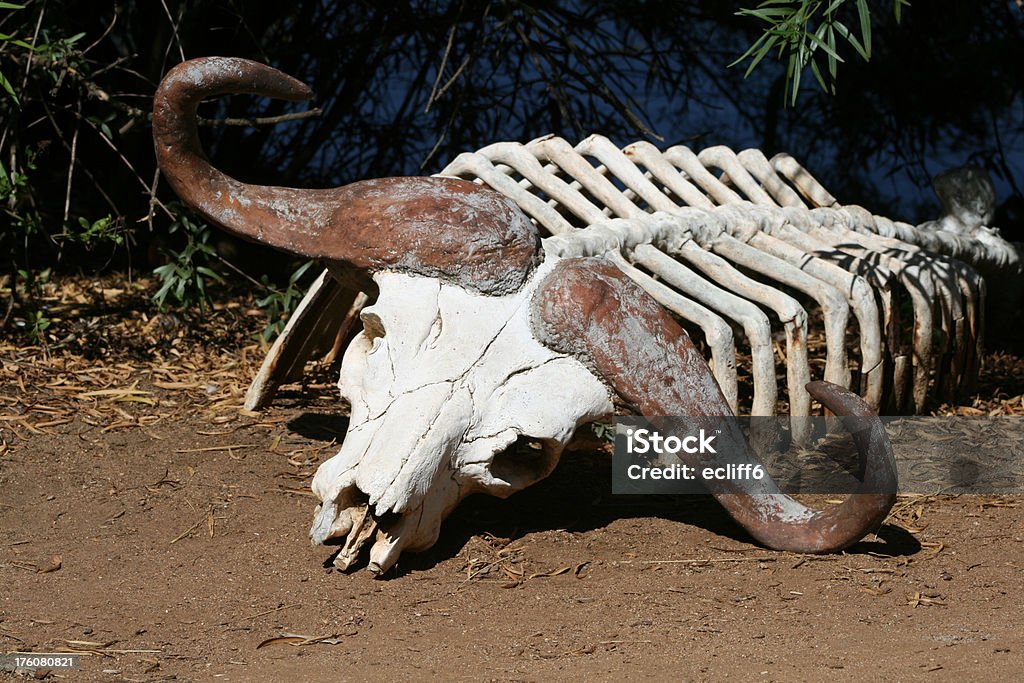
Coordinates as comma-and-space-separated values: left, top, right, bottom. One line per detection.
0, 276, 1024, 681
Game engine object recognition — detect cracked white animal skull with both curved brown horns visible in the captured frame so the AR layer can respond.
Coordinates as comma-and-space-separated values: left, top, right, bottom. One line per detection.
154, 57, 896, 573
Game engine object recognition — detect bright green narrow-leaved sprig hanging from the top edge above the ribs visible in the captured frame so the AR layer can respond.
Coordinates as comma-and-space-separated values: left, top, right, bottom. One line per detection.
729, 0, 910, 105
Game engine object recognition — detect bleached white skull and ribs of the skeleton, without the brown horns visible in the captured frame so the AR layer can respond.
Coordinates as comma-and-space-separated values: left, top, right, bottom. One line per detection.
239, 135, 1002, 572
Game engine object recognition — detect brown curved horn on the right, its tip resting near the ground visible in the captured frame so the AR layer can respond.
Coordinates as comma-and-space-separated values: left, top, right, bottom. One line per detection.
532, 258, 896, 553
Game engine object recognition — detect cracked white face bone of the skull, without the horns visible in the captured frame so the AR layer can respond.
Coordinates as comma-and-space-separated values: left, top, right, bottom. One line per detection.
310, 260, 612, 572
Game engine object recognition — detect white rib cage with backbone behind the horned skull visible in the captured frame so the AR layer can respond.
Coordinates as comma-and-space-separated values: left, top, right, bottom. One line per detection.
247, 135, 1016, 416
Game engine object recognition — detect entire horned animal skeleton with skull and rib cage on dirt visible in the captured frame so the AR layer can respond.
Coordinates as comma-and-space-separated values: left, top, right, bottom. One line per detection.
154, 57, 958, 573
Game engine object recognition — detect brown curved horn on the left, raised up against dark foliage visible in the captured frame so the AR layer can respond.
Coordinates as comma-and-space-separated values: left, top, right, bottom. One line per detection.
153, 57, 541, 294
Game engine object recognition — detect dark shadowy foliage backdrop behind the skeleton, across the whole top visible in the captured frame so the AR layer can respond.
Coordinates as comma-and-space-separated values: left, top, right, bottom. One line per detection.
0, 0, 1024, 342
